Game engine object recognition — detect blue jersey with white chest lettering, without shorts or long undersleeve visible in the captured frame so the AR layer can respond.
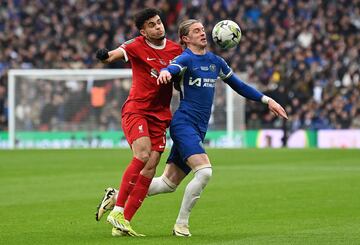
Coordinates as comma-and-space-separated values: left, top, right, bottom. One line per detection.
168, 49, 232, 132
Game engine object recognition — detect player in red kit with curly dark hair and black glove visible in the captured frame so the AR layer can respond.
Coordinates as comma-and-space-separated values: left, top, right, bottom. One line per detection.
96, 9, 182, 236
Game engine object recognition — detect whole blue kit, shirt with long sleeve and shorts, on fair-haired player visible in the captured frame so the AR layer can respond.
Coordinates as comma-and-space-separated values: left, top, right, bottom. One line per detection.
164, 49, 263, 174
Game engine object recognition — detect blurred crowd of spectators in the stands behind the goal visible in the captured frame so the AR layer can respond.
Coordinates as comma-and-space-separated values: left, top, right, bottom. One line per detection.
0, 0, 360, 131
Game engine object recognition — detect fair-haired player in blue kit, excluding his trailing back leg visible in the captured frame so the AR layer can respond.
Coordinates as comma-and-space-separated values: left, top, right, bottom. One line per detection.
157, 20, 287, 236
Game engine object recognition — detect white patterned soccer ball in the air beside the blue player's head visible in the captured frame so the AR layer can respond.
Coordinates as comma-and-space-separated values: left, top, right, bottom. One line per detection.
212, 20, 241, 49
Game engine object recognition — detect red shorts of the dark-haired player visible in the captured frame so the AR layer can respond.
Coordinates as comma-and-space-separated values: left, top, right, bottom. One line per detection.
121, 114, 170, 152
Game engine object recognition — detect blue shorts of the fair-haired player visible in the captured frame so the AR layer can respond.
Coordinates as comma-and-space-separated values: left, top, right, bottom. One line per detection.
167, 113, 206, 174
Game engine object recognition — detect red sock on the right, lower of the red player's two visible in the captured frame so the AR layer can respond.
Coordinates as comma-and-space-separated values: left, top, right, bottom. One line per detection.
124, 174, 152, 221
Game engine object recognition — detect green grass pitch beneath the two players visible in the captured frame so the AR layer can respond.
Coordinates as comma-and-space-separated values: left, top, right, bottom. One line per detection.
0, 149, 360, 245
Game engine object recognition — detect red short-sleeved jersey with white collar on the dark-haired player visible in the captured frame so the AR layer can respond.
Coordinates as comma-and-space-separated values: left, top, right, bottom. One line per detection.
120, 36, 182, 120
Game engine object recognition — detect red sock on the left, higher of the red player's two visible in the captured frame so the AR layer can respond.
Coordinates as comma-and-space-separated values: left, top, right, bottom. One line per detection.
116, 157, 144, 207
